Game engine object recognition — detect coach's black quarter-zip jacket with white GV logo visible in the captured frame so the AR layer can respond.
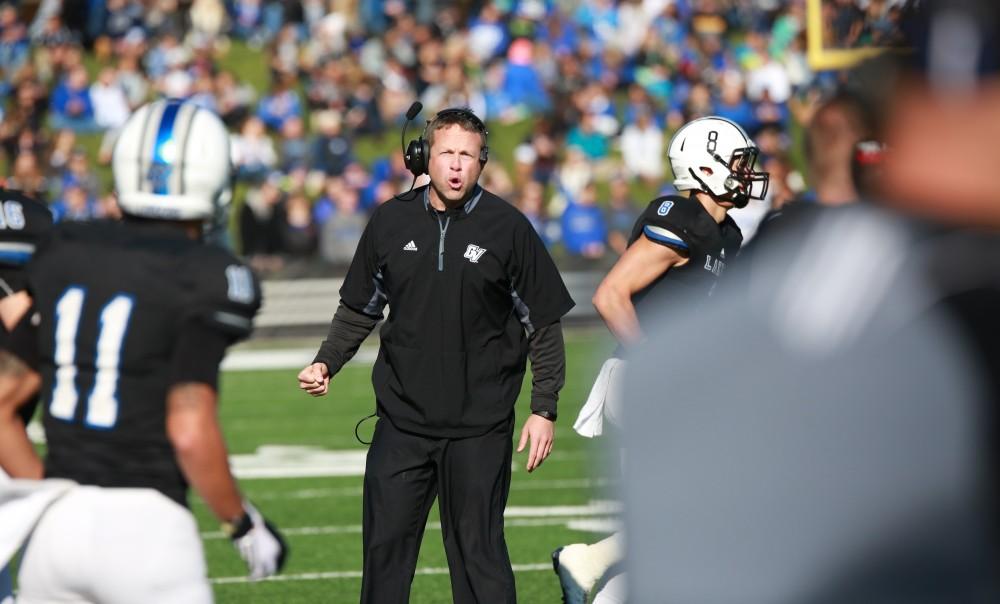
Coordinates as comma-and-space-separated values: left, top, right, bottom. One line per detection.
340, 187, 573, 437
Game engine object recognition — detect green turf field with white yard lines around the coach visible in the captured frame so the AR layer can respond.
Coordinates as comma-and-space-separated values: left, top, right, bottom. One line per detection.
192, 329, 615, 604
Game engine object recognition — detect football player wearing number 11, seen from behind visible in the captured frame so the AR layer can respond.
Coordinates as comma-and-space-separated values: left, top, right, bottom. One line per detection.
0, 100, 287, 603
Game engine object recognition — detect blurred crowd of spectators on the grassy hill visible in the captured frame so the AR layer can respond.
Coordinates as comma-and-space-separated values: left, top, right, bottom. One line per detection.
0, 0, 903, 271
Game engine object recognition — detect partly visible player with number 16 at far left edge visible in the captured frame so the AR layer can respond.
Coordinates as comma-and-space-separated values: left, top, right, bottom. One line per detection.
0, 188, 52, 604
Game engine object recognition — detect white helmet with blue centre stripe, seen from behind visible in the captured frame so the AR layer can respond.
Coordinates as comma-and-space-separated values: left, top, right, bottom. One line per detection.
111, 99, 232, 220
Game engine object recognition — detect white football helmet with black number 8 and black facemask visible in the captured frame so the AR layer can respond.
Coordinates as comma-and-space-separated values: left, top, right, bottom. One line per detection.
667, 116, 768, 208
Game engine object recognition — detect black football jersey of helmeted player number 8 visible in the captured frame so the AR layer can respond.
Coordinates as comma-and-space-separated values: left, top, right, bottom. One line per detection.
629, 195, 743, 321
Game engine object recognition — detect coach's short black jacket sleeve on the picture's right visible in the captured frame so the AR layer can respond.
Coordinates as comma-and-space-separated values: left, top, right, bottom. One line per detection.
508, 216, 575, 332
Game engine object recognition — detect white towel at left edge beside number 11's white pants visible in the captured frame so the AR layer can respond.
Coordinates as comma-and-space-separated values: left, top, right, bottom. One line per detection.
0, 478, 77, 567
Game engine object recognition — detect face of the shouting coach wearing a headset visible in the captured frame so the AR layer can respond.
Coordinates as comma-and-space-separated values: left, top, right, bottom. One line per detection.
427, 124, 483, 209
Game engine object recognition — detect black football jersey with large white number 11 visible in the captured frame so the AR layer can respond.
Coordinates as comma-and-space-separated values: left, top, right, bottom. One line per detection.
28, 222, 260, 505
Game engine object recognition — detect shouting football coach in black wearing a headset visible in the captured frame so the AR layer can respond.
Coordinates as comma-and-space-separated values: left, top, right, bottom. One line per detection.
298, 105, 573, 604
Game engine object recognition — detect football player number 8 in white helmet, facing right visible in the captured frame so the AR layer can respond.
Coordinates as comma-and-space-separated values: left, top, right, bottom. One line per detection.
552, 117, 768, 603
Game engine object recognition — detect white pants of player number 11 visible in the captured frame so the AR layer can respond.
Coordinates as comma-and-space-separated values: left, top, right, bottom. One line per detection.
17, 486, 212, 604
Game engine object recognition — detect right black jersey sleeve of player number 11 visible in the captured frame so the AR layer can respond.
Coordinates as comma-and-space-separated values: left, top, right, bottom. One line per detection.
180, 249, 261, 344
